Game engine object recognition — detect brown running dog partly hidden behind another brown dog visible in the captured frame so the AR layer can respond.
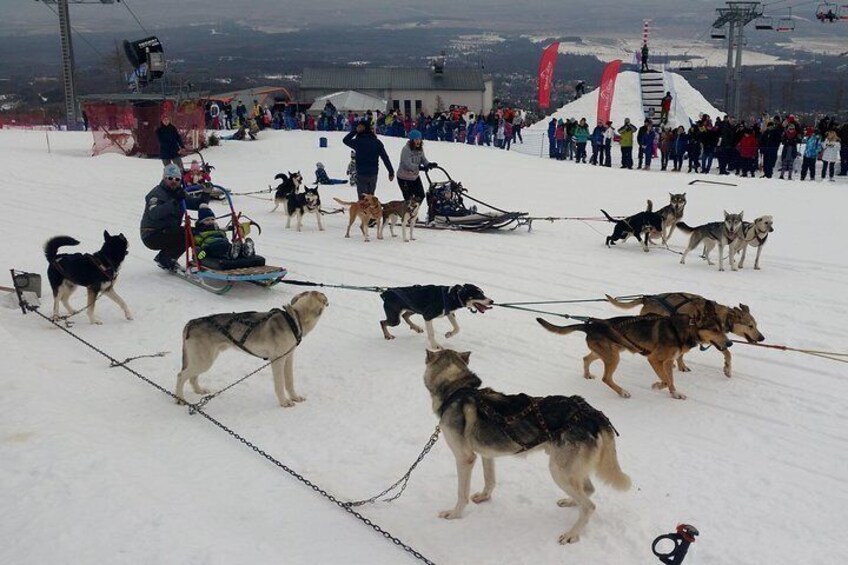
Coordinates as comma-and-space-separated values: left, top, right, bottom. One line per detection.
606, 292, 766, 378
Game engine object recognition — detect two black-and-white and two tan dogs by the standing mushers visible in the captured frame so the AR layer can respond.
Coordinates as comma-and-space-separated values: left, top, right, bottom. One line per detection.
271, 171, 421, 243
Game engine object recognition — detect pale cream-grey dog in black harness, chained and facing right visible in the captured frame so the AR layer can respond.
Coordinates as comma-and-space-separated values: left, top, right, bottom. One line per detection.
174, 290, 329, 407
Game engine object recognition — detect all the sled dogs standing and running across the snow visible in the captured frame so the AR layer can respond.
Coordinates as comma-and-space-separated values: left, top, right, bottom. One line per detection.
39, 187, 773, 544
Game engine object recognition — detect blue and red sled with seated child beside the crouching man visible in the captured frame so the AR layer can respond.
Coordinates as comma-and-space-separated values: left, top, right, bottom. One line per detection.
172, 184, 288, 294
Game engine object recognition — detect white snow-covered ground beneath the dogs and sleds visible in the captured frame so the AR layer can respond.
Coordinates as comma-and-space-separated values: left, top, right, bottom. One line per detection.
0, 131, 848, 565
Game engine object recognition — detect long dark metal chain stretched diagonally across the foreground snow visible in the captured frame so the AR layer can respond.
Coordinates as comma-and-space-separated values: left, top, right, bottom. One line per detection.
16, 300, 438, 565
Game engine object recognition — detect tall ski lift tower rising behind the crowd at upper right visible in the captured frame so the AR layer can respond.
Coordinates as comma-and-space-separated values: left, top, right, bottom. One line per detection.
712, 2, 763, 116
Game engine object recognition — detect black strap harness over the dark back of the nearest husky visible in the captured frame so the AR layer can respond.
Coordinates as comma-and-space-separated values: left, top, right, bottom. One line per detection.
439, 374, 619, 454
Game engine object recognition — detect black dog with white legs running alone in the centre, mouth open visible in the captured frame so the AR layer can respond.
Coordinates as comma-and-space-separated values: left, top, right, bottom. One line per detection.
380, 283, 494, 349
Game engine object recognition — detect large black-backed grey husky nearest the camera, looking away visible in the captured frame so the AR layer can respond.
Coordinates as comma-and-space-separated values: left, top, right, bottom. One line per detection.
424, 349, 630, 544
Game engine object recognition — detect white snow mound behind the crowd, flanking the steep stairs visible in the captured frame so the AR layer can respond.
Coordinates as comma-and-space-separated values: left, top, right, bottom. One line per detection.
528, 71, 723, 131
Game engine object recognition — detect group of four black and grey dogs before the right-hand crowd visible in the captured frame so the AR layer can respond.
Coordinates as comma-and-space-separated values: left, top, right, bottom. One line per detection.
601, 192, 774, 271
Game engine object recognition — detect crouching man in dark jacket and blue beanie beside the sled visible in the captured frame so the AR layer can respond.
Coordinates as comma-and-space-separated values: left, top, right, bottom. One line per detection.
141, 163, 200, 271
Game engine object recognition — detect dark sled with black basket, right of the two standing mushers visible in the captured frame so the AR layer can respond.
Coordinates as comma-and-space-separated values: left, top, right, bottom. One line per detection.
416, 167, 533, 231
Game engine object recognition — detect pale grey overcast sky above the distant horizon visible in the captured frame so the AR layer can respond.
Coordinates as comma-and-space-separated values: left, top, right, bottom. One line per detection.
0, 0, 821, 37
